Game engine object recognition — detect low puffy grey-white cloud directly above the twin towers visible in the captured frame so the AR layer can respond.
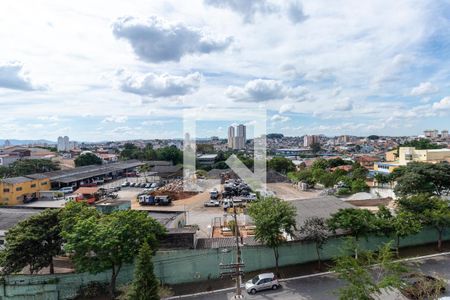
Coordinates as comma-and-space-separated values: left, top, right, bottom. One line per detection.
225, 79, 308, 102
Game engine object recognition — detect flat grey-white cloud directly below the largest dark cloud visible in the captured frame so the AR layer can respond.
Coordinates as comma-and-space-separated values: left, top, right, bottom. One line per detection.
117, 71, 202, 97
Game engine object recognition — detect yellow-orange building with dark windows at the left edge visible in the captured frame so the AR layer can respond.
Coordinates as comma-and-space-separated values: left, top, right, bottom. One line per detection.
0, 174, 50, 205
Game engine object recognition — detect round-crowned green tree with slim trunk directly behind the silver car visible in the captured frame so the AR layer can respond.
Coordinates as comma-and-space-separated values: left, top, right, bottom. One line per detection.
248, 197, 296, 275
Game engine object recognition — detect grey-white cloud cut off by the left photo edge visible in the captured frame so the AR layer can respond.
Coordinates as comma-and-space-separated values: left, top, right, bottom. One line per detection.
0, 61, 44, 91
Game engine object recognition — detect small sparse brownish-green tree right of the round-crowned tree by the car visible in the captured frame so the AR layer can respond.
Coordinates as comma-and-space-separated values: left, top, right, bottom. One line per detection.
299, 217, 329, 270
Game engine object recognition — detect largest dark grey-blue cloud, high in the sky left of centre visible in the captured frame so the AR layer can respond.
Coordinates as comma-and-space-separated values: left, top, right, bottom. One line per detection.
113, 16, 233, 63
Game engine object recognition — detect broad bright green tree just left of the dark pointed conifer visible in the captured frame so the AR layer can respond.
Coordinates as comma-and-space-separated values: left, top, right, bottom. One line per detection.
63, 210, 165, 298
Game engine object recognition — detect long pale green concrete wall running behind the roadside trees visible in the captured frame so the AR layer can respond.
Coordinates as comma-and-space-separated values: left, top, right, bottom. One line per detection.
0, 229, 450, 300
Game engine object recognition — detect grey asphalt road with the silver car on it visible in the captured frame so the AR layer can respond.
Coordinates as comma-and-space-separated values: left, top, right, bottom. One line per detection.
174, 255, 450, 300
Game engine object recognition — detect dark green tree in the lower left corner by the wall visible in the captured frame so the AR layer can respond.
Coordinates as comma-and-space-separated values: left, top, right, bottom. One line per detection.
0, 209, 63, 274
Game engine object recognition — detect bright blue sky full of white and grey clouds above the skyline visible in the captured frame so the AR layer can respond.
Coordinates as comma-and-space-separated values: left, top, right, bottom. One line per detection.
0, 0, 450, 141
